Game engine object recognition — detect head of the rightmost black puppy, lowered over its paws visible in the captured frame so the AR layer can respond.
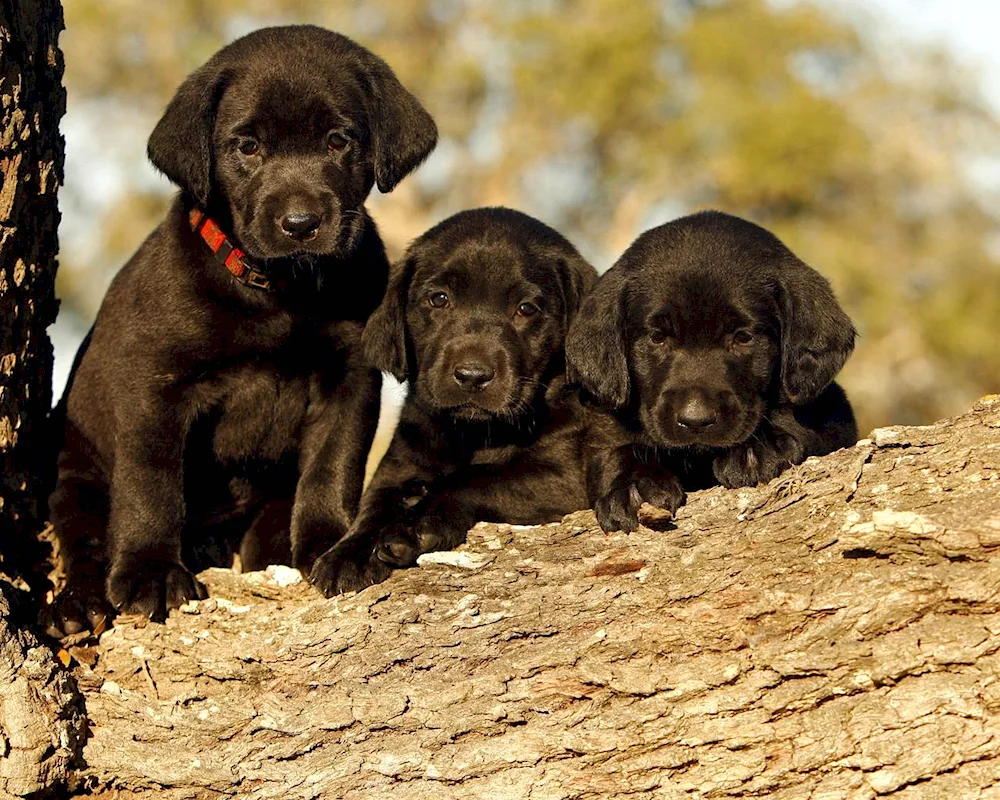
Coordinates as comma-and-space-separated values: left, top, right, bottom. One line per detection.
567, 212, 855, 447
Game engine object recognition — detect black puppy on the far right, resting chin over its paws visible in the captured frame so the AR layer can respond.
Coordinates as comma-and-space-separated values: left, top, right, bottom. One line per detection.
566, 211, 857, 531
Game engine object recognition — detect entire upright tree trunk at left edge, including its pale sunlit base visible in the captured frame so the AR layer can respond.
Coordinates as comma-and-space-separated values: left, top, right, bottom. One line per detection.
0, 0, 83, 798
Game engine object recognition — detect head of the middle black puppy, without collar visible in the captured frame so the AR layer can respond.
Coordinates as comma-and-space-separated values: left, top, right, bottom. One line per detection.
364, 208, 597, 419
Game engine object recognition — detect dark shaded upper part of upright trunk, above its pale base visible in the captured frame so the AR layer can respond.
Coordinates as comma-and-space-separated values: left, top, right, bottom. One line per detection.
0, 0, 66, 572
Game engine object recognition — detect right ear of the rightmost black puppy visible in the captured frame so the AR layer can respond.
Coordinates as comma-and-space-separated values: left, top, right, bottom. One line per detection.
779, 256, 856, 405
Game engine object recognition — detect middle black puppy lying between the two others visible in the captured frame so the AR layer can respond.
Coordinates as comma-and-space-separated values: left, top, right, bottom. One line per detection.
312, 208, 597, 595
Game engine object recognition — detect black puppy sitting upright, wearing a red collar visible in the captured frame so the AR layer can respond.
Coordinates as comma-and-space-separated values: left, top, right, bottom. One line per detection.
50, 26, 437, 632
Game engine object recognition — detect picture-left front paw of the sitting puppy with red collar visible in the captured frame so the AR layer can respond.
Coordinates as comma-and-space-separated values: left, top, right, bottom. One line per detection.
107, 559, 208, 622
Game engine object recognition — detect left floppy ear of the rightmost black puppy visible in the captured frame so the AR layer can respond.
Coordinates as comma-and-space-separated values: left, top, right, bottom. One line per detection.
566, 267, 629, 408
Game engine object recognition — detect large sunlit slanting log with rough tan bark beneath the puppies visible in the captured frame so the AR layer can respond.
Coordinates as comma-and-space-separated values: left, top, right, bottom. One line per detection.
62, 398, 1000, 800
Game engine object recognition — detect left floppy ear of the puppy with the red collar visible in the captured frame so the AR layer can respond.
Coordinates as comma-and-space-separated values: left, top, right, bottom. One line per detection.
146, 63, 228, 205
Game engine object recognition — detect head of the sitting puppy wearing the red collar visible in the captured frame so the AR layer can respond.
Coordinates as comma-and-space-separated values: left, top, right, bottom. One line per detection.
148, 25, 437, 259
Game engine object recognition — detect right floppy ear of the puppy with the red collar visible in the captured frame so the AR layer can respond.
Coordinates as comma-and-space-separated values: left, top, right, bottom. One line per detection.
365, 53, 437, 192
